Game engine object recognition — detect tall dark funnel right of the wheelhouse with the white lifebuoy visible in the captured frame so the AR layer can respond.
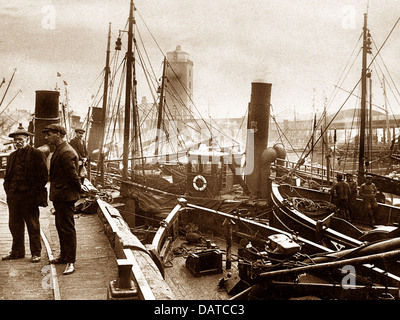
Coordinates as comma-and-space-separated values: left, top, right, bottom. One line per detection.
245, 82, 272, 197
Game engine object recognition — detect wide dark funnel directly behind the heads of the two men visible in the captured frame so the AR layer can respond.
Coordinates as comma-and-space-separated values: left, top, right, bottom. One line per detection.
34, 90, 60, 148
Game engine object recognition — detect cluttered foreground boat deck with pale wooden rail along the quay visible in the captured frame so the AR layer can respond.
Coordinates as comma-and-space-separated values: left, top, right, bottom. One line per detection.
98, 195, 400, 300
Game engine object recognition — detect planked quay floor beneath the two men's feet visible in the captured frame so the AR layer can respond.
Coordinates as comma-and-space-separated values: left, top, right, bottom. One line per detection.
0, 182, 118, 300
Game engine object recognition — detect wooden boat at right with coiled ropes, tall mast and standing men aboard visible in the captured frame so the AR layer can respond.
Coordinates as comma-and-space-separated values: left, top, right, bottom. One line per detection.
260, 15, 400, 292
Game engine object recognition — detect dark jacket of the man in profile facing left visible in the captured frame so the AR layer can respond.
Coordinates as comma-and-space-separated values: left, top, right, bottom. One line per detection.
50, 141, 81, 201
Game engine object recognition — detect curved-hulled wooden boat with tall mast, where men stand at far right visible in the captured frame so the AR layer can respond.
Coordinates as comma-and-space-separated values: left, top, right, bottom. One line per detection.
273, 11, 400, 240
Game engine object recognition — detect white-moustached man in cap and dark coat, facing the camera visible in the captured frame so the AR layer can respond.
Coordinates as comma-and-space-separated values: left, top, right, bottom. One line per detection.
2, 126, 48, 262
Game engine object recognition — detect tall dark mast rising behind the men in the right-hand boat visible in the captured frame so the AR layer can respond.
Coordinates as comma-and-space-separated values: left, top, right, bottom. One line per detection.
358, 13, 368, 185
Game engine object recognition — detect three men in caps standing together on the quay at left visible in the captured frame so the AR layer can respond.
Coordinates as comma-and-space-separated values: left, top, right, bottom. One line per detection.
2, 124, 87, 275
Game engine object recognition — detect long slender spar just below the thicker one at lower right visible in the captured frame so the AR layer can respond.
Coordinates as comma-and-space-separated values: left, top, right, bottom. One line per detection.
259, 250, 400, 279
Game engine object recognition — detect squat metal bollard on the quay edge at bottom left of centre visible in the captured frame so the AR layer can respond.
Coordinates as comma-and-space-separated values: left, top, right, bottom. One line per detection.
107, 259, 139, 300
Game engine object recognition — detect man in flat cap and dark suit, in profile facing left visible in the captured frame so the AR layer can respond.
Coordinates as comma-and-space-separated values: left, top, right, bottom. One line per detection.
43, 124, 82, 274
